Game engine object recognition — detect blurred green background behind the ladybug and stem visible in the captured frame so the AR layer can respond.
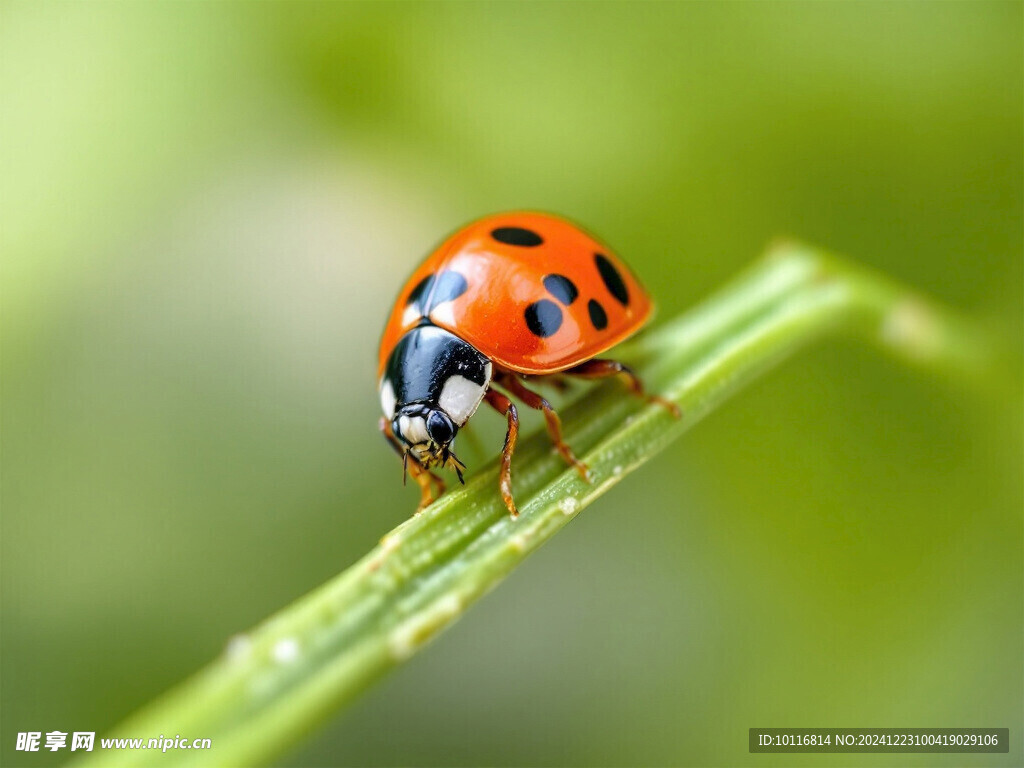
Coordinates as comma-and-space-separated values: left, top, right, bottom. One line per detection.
0, 2, 1024, 766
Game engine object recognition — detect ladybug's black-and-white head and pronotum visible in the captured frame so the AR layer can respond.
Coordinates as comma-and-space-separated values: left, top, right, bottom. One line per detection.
381, 325, 490, 480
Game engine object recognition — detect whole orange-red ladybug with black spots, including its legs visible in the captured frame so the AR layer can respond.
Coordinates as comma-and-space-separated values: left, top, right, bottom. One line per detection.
378, 212, 678, 517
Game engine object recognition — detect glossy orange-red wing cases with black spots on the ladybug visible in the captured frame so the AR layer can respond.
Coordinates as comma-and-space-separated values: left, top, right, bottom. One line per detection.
378, 212, 653, 376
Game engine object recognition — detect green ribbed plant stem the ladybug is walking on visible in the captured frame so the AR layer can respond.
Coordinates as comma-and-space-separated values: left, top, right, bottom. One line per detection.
77, 244, 989, 766
